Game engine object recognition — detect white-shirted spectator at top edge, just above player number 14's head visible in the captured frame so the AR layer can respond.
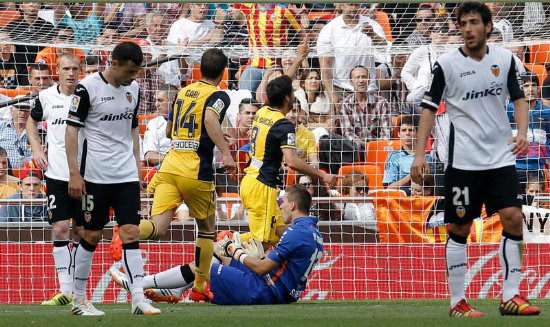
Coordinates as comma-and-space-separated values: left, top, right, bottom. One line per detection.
168, 3, 219, 52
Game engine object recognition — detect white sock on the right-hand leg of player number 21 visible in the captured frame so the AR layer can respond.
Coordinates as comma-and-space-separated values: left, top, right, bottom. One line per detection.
499, 232, 523, 302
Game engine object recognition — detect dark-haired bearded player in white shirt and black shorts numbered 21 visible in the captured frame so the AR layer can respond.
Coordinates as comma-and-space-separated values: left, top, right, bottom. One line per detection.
411, 2, 540, 317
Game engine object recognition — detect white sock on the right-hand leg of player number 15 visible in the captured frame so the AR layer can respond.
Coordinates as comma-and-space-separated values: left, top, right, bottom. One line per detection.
122, 241, 145, 304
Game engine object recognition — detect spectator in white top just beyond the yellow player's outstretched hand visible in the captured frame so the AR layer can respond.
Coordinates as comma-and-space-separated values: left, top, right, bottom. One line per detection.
341, 172, 376, 223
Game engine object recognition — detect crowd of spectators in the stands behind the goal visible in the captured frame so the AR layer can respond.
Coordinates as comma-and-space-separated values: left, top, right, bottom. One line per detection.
0, 2, 550, 222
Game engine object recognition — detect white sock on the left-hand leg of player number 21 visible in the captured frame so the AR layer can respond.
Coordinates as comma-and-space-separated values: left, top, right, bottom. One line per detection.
445, 233, 467, 308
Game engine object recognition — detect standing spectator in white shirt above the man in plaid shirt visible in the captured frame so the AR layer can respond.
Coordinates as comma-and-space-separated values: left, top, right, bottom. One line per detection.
317, 3, 386, 105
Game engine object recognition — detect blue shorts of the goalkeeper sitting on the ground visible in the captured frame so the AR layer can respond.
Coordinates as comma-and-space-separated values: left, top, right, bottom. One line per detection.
210, 260, 277, 305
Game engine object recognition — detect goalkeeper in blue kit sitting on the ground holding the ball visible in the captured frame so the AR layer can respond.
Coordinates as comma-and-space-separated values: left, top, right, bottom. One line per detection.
111, 185, 323, 305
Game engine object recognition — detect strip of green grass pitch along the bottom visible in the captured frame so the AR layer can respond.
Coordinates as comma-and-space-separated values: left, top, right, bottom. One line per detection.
0, 300, 550, 327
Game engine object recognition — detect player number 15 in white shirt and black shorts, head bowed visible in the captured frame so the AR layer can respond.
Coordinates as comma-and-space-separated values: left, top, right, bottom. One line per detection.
65, 42, 161, 316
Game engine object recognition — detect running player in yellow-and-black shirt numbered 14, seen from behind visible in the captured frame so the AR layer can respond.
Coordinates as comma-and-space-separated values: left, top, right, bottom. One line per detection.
140, 49, 236, 302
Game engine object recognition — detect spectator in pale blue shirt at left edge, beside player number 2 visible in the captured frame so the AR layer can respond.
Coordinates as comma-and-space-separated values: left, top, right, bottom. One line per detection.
0, 96, 32, 169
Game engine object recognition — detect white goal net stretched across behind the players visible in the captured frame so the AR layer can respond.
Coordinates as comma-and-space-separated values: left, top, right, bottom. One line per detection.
0, 1, 550, 303
